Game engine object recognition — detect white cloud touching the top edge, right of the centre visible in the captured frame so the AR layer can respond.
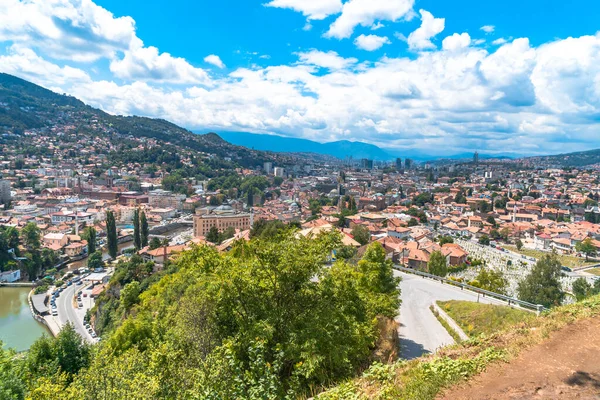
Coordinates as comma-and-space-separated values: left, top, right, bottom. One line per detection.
325, 0, 414, 39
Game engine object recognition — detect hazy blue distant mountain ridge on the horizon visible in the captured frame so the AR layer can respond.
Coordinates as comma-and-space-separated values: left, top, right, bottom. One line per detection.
211, 132, 395, 161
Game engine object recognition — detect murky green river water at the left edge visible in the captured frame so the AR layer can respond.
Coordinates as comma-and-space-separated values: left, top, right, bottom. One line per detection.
0, 287, 50, 351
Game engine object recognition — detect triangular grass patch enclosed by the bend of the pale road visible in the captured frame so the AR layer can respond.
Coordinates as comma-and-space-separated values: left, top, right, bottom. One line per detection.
438, 300, 535, 337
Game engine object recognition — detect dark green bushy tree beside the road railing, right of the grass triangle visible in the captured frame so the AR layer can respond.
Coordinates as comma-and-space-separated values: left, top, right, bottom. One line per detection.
517, 254, 565, 307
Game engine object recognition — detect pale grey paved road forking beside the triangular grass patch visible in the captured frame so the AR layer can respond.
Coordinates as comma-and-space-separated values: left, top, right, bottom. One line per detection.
395, 271, 504, 360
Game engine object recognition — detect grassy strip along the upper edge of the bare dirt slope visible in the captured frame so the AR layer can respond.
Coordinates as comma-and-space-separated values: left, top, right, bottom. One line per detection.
316, 296, 600, 400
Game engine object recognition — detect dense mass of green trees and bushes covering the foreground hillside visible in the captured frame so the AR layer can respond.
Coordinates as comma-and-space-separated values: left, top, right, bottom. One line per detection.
0, 228, 400, 399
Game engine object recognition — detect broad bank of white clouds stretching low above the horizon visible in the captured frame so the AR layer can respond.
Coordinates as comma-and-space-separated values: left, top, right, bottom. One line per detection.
0, 0, 600, 155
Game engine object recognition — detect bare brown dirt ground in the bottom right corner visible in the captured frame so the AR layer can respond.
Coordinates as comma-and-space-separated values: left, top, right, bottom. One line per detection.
440, 318, 600, 400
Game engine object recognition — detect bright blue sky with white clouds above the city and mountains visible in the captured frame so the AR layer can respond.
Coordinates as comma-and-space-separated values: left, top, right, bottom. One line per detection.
0, 0, 600, 156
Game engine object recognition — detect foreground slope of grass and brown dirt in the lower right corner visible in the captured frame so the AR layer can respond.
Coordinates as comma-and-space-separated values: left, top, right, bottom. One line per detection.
316, 296, 600, 400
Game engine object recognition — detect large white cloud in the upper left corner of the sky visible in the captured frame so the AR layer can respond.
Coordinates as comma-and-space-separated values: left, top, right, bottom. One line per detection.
0, 0, 207, 83
